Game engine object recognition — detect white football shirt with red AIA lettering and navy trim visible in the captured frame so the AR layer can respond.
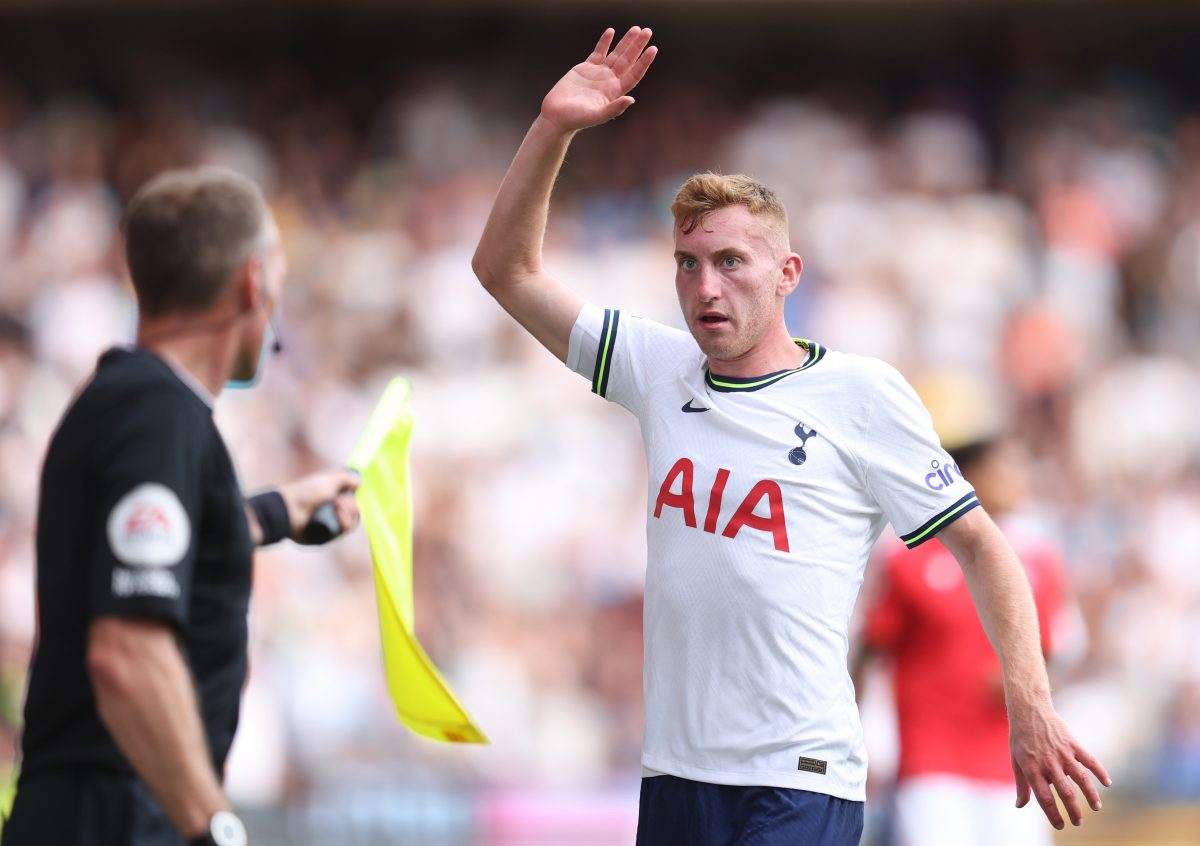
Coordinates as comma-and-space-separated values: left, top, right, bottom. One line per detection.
568, 304, 979, 800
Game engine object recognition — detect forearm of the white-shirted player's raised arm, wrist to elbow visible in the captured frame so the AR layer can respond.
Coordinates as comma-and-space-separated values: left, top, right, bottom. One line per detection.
472, 116, 575, 290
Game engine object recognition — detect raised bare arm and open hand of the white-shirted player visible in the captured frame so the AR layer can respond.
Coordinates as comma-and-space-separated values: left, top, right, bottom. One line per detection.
472, 26, 656, 361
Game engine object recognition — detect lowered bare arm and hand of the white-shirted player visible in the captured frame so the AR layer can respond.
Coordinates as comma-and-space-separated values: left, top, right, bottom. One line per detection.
937, 509, 1112, 828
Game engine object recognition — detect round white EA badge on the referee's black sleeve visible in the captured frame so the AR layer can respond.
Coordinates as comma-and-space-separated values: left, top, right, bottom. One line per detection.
108, 482, 192, 568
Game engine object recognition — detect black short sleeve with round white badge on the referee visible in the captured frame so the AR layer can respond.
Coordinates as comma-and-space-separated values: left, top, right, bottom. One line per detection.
88, 391, 208, 625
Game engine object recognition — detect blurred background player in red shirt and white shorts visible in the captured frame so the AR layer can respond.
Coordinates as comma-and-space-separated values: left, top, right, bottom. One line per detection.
851, 391, 1072, 846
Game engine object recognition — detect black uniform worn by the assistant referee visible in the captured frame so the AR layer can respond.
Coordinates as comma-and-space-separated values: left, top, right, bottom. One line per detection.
4, 349, 252, 846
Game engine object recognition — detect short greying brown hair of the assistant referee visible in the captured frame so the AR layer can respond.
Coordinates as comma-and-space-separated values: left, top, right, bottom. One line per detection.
121, 167, 270, 317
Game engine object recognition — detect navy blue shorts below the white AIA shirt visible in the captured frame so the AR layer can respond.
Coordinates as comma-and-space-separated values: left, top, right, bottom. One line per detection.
637, 775, 863, 846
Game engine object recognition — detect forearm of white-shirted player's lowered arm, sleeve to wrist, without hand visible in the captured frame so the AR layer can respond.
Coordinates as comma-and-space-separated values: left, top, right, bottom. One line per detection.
943, 509, 1050, 710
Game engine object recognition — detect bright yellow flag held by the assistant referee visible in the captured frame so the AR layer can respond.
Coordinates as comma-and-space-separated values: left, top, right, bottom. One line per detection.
349, 377, 487, 743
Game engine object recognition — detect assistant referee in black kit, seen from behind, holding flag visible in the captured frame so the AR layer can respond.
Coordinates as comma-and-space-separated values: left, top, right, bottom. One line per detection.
4, 169, 358, 846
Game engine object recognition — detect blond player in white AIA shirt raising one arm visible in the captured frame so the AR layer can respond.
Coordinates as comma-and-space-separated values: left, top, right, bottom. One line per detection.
473, 26, 1109, 846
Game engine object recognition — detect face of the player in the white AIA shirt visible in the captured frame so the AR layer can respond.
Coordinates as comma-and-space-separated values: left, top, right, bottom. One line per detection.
674, 205, 799, 361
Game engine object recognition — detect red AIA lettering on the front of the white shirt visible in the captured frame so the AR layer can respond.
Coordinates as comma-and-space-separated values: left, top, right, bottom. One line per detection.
654, 458, 791, 552
